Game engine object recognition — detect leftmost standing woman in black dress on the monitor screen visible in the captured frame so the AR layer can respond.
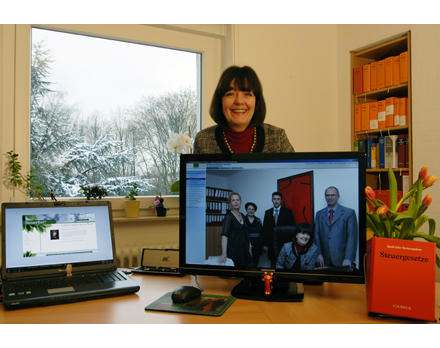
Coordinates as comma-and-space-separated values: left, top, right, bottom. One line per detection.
219, 192, 252, 269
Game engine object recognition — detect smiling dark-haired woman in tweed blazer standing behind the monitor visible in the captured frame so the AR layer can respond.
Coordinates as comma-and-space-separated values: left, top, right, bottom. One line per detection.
194, 66, 294, 153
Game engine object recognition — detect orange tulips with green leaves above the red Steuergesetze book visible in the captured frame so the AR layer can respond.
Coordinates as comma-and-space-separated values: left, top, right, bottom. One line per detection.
365, 166, 440, 267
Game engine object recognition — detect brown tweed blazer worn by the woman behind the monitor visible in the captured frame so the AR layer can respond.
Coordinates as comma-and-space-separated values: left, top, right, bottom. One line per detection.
194, 123, 295, 153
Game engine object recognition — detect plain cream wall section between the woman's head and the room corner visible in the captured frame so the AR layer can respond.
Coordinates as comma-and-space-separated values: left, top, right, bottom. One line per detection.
235, 24, 338, 151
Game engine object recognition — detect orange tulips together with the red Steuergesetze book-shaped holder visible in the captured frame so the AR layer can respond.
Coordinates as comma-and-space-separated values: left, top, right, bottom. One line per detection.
365, 166, 440, 320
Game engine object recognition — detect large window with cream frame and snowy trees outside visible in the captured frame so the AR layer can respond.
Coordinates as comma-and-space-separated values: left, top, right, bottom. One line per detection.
2, 25, 227, 201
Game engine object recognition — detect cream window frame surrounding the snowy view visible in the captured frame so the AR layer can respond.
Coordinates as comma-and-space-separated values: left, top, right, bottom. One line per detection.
0, 24, 227, 206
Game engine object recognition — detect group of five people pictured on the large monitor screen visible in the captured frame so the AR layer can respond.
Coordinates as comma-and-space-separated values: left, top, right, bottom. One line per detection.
219, 186, 358, 272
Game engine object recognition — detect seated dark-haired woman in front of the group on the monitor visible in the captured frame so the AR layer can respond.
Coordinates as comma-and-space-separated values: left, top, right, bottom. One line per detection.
276, 222, 319, 272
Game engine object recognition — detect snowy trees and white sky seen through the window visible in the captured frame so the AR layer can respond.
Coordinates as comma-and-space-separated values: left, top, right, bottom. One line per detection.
31, 28, 201, 197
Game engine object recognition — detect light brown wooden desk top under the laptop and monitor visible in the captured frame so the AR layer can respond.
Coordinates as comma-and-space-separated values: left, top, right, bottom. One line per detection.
0, 275, 440, 324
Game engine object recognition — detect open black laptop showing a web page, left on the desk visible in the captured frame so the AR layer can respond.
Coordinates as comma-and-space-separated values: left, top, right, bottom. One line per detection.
1, 200, 139, 309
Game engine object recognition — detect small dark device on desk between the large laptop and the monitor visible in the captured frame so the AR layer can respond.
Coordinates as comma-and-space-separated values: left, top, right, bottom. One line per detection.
132, 248, 183, 276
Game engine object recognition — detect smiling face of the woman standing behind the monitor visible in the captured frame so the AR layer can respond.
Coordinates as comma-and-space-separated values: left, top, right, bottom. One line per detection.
222, 80, 256, 132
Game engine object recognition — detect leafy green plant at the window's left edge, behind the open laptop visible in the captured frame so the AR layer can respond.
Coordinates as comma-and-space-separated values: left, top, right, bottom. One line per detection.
4, 150, 44, 200
